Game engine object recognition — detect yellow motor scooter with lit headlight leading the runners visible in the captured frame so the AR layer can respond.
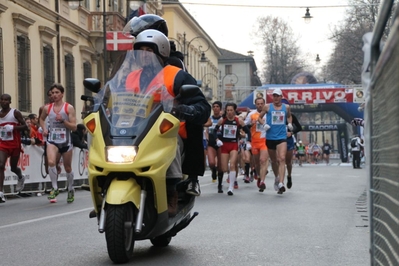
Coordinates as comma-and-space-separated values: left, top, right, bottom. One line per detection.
81, 51, 198, 263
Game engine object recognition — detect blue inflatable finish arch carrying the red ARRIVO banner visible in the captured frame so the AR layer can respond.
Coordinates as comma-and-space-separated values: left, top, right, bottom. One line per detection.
239, 84, 364, 162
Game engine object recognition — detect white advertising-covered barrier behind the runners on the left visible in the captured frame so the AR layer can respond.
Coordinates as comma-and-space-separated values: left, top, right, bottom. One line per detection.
4, 145, 88, 195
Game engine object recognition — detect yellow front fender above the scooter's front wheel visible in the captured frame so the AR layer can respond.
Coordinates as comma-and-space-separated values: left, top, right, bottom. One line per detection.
106, 178, 141, 209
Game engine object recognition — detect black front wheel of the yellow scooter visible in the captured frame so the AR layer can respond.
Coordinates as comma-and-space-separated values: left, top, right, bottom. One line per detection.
105, 203, 134, 263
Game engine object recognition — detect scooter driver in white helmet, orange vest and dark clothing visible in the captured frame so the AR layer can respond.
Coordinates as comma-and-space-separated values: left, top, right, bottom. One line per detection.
126, 29, 211, 216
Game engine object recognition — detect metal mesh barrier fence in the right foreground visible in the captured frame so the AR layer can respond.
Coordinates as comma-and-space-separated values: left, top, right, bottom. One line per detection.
365, 0, 399, 266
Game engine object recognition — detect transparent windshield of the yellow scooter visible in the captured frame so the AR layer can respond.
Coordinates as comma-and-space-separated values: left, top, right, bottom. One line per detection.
95, 50, 173, 128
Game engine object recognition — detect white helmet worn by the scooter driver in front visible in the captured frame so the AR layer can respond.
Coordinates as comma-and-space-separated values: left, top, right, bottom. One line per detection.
134, 30, 170, 59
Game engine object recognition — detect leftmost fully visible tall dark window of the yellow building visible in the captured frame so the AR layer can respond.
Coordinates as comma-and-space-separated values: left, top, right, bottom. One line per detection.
17, 34, 31, 113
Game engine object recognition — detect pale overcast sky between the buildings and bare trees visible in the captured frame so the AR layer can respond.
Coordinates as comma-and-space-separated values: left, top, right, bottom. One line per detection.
180, 0, 347, 71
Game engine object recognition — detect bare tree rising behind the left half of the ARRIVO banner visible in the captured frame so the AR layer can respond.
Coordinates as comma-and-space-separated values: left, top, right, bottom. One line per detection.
257, 16, 306, 84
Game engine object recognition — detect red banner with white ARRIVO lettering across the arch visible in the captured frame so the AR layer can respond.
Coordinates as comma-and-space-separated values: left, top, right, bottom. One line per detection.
253, 87, 353, 104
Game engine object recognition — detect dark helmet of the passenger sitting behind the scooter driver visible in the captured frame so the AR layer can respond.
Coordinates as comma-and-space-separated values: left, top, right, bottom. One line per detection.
123, 14, 168, 37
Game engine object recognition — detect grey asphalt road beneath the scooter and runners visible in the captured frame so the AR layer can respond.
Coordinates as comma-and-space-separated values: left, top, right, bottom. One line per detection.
0, 164, 370, 266
